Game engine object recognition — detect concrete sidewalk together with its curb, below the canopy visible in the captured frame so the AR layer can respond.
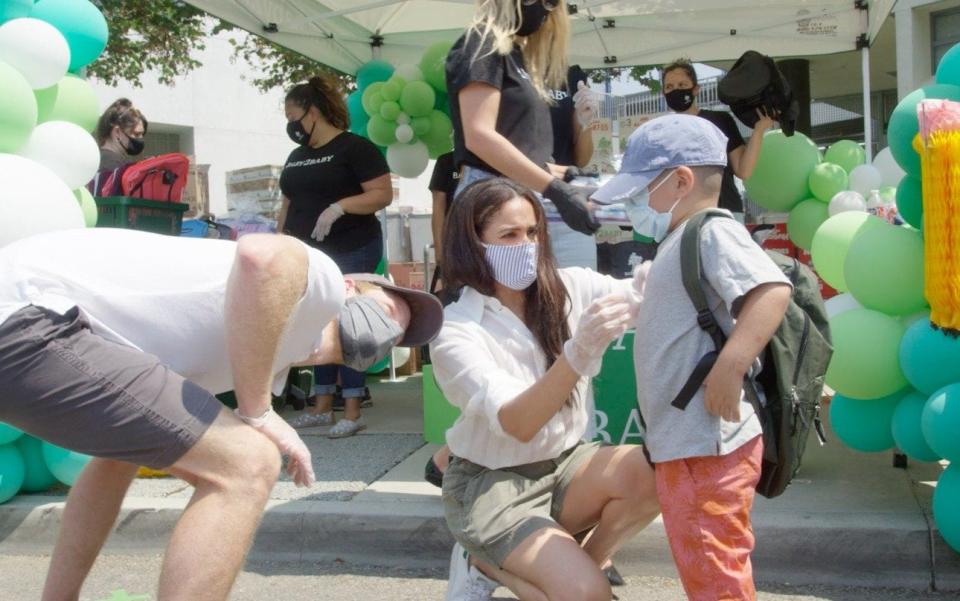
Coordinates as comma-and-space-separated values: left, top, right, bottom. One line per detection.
0, 376, 960, 591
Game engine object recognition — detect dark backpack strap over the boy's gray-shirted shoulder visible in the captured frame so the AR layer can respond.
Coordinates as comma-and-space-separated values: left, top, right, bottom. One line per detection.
670, 209, 760, 415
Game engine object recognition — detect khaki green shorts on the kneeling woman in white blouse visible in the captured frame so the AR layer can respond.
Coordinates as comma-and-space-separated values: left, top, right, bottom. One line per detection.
443, 442, 600, 567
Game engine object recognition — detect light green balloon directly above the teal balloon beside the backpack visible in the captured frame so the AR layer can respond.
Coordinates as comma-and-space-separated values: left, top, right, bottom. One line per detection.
826, 309, 907, 399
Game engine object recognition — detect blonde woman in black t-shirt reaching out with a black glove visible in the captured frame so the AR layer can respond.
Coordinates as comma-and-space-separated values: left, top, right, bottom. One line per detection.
446, 0, 598, 234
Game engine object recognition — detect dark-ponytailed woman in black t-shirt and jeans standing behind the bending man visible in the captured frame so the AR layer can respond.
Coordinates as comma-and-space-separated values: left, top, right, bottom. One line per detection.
278, 76, 393, 438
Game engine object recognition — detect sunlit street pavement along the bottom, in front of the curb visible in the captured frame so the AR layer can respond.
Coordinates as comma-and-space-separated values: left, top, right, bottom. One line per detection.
0, 556, 960, 601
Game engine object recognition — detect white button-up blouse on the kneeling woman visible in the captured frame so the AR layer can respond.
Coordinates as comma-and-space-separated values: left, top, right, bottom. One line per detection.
430, 267, 632, 469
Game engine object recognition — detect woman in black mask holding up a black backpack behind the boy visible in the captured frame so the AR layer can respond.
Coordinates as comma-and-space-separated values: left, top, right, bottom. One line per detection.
660, 59, 776, 220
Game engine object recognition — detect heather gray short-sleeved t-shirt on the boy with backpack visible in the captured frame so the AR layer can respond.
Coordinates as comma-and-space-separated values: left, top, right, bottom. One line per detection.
633, 217, 790, 462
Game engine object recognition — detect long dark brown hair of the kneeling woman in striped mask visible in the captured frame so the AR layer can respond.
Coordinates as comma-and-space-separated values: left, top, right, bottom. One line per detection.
441, 177, 570, 366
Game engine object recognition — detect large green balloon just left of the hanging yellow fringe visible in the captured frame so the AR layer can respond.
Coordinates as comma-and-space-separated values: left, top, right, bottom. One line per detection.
843, 223, 927, 315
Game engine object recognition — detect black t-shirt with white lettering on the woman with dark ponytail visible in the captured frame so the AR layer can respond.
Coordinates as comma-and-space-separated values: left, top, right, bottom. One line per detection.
280, 132, 390, 252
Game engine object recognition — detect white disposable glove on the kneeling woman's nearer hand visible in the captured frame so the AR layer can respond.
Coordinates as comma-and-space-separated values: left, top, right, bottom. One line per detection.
563, 294, 630, 378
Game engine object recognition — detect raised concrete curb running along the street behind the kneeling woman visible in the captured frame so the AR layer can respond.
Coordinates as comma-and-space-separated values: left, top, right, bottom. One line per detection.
0, 497, 960, 591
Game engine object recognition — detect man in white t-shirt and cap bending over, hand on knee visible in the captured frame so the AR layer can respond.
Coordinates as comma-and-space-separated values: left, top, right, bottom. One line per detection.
0, 228, 443, 599
